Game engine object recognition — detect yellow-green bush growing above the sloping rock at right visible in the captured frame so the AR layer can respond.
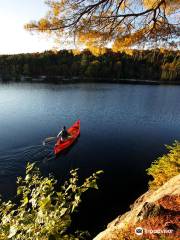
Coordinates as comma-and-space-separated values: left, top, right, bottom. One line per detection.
147, 141, 180, 189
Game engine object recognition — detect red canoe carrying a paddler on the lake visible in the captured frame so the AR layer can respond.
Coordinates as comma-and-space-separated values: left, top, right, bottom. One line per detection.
54, 120, 80, 154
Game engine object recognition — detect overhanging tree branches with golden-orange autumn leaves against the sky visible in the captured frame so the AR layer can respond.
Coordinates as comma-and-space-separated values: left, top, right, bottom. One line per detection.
25, 0, 180, 49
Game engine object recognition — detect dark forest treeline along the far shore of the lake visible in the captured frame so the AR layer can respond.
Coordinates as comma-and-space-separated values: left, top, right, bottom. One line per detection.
0, 49, 180, 82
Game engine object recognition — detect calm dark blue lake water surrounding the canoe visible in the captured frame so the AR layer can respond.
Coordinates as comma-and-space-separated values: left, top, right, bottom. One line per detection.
0, 84, 180, 234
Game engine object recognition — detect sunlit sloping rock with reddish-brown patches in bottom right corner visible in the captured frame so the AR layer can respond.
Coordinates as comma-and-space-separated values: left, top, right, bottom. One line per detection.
94, 174, 180, 240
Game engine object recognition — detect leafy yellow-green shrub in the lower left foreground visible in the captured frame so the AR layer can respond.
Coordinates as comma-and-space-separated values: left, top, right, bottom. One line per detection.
0, 164, 102, 240
